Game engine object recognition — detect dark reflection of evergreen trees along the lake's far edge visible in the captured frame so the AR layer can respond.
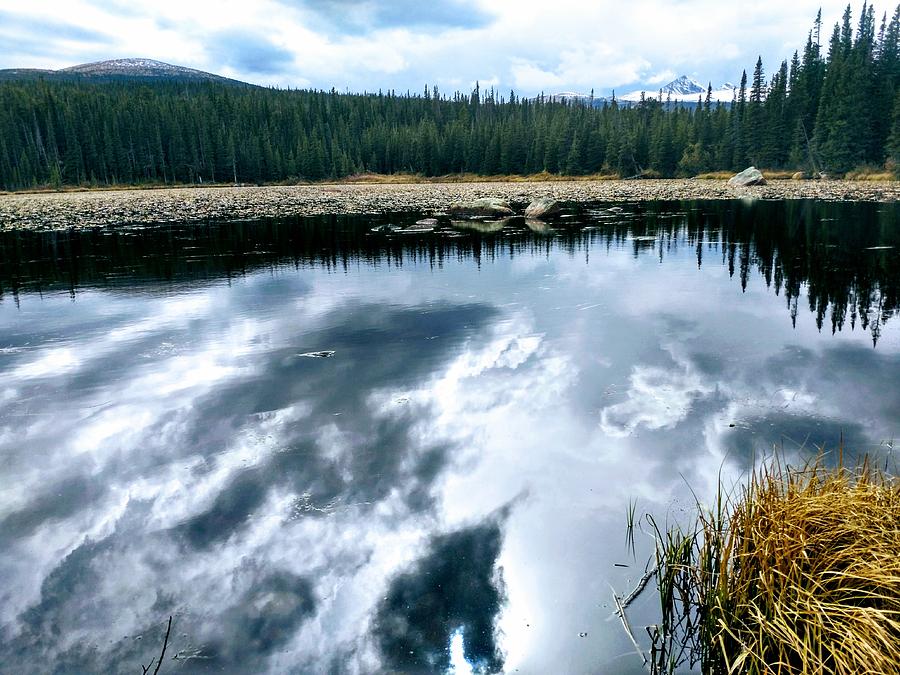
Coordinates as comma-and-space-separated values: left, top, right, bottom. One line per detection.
0, 200, 900, 342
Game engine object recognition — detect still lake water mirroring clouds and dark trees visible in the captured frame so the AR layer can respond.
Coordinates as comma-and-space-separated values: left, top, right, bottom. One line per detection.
0, 202, 900, 673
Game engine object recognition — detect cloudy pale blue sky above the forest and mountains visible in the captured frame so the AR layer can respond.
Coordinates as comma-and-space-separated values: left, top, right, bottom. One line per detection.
0, 0, 872, 95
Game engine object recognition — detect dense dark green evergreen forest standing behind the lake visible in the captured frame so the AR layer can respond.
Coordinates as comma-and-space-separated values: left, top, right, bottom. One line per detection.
0, 4, 900, 190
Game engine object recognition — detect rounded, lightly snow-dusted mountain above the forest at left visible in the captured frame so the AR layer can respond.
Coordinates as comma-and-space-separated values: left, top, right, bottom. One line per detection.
0, 59, 252, 87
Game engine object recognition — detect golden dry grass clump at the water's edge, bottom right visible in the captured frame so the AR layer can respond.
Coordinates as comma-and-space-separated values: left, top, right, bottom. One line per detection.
648, 457, 900, 675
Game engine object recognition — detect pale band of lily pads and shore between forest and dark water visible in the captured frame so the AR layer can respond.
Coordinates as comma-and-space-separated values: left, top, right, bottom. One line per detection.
0, 180, 900, 229
